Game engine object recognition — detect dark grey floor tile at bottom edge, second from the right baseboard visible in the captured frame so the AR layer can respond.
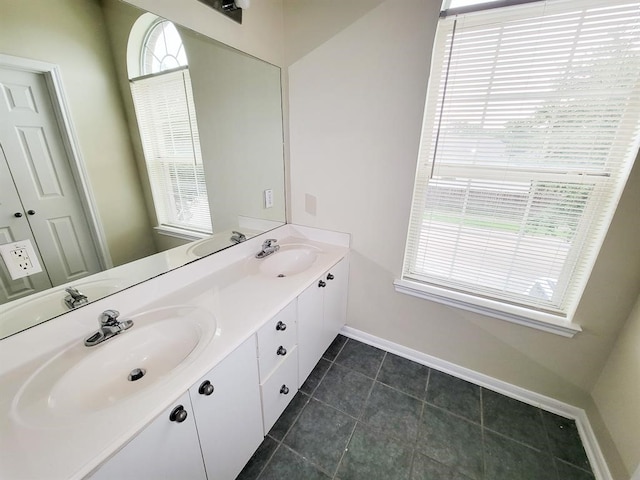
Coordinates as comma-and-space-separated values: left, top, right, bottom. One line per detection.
484, 430, 564, 480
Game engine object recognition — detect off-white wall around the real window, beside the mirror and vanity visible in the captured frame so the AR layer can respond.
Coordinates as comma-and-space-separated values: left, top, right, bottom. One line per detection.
285, 0, 640, 474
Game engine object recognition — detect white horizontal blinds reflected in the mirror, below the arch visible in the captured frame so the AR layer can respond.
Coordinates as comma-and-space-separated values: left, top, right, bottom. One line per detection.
131, 69, 211, 232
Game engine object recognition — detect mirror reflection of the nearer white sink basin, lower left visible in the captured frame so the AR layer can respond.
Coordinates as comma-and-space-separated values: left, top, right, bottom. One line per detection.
0, 279, 128, 338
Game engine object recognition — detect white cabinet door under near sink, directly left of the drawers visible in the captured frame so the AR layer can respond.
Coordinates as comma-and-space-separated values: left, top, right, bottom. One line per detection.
188, 335, 263, 480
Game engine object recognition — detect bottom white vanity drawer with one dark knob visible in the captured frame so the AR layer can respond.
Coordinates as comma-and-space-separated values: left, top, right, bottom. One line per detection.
260, 347, 298, 435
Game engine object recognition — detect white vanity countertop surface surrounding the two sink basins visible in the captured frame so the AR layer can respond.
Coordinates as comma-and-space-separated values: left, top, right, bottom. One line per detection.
0, 225, 349, 480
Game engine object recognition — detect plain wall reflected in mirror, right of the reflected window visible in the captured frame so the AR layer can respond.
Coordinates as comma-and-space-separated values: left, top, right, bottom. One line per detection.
181, 29, 285, 233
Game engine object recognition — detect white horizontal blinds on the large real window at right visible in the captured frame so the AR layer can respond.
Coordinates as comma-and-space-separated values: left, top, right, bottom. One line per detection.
404, 0, 640, 316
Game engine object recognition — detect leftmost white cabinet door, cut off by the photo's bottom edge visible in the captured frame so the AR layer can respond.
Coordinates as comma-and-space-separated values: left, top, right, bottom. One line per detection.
90, 393, 207, 480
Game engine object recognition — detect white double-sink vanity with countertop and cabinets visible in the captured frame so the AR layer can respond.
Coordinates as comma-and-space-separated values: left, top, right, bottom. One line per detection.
0, 225, 349, 480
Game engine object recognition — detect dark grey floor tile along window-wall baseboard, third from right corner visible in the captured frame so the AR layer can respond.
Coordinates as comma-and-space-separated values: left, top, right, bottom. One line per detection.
426, 369, 480, 423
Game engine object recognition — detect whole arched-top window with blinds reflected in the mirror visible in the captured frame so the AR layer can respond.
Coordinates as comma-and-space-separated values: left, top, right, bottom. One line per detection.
128, 15, 212, 238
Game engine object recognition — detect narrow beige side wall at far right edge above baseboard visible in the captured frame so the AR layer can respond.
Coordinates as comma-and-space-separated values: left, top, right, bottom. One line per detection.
592, 297, 640, 474
